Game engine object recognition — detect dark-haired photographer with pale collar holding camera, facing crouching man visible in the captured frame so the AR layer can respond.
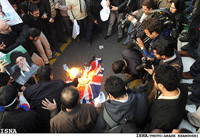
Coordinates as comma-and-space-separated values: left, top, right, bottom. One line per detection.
145, 37, 183, 102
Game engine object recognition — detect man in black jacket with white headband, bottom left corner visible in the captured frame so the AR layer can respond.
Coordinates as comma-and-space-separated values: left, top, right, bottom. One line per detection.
0, 85, 40, 133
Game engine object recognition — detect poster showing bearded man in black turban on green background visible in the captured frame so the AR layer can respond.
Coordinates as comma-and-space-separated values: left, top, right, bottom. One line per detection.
0, 46, 39, 85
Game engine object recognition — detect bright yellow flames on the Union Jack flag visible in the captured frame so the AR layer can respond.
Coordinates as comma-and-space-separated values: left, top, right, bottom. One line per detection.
67, 68, 95, 85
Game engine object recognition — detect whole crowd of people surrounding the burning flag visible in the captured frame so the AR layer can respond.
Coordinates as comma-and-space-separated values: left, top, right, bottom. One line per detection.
0, 0, 200, 133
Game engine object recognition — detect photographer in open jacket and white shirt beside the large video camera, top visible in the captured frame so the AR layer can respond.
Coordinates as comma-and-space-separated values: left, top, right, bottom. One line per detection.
123, 0, 153, 45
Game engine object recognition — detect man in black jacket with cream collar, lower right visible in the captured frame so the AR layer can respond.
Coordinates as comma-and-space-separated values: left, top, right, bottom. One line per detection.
145, 65, 188, 133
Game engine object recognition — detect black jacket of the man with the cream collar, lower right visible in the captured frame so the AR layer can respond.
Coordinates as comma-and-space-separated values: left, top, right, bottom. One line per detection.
145, 85, 188, 133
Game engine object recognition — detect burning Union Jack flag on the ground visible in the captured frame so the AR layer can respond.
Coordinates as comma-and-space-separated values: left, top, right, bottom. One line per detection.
64, 58, 104, 105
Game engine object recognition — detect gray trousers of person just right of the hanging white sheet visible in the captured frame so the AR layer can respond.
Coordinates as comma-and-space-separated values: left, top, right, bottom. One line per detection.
107, 11, 124, 38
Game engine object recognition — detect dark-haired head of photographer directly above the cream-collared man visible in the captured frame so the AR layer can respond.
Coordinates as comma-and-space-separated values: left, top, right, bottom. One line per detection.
152, 38, 174, 60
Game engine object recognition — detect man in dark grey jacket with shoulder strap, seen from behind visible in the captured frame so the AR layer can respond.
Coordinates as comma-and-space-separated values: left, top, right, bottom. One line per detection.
93, 76, 148, 132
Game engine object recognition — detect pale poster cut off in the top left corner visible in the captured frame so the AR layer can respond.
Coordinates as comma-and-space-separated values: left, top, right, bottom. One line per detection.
0, 0, 23, 26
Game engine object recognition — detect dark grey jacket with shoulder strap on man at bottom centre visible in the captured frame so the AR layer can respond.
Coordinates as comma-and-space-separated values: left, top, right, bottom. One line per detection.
93, 89, 149, 132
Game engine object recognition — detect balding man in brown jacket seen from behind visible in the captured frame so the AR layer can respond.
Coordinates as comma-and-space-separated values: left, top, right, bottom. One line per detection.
50, 87, 97, 133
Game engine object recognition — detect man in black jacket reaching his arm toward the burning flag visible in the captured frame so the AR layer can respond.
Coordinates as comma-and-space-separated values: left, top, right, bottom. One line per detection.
24, 66, 78, 132
